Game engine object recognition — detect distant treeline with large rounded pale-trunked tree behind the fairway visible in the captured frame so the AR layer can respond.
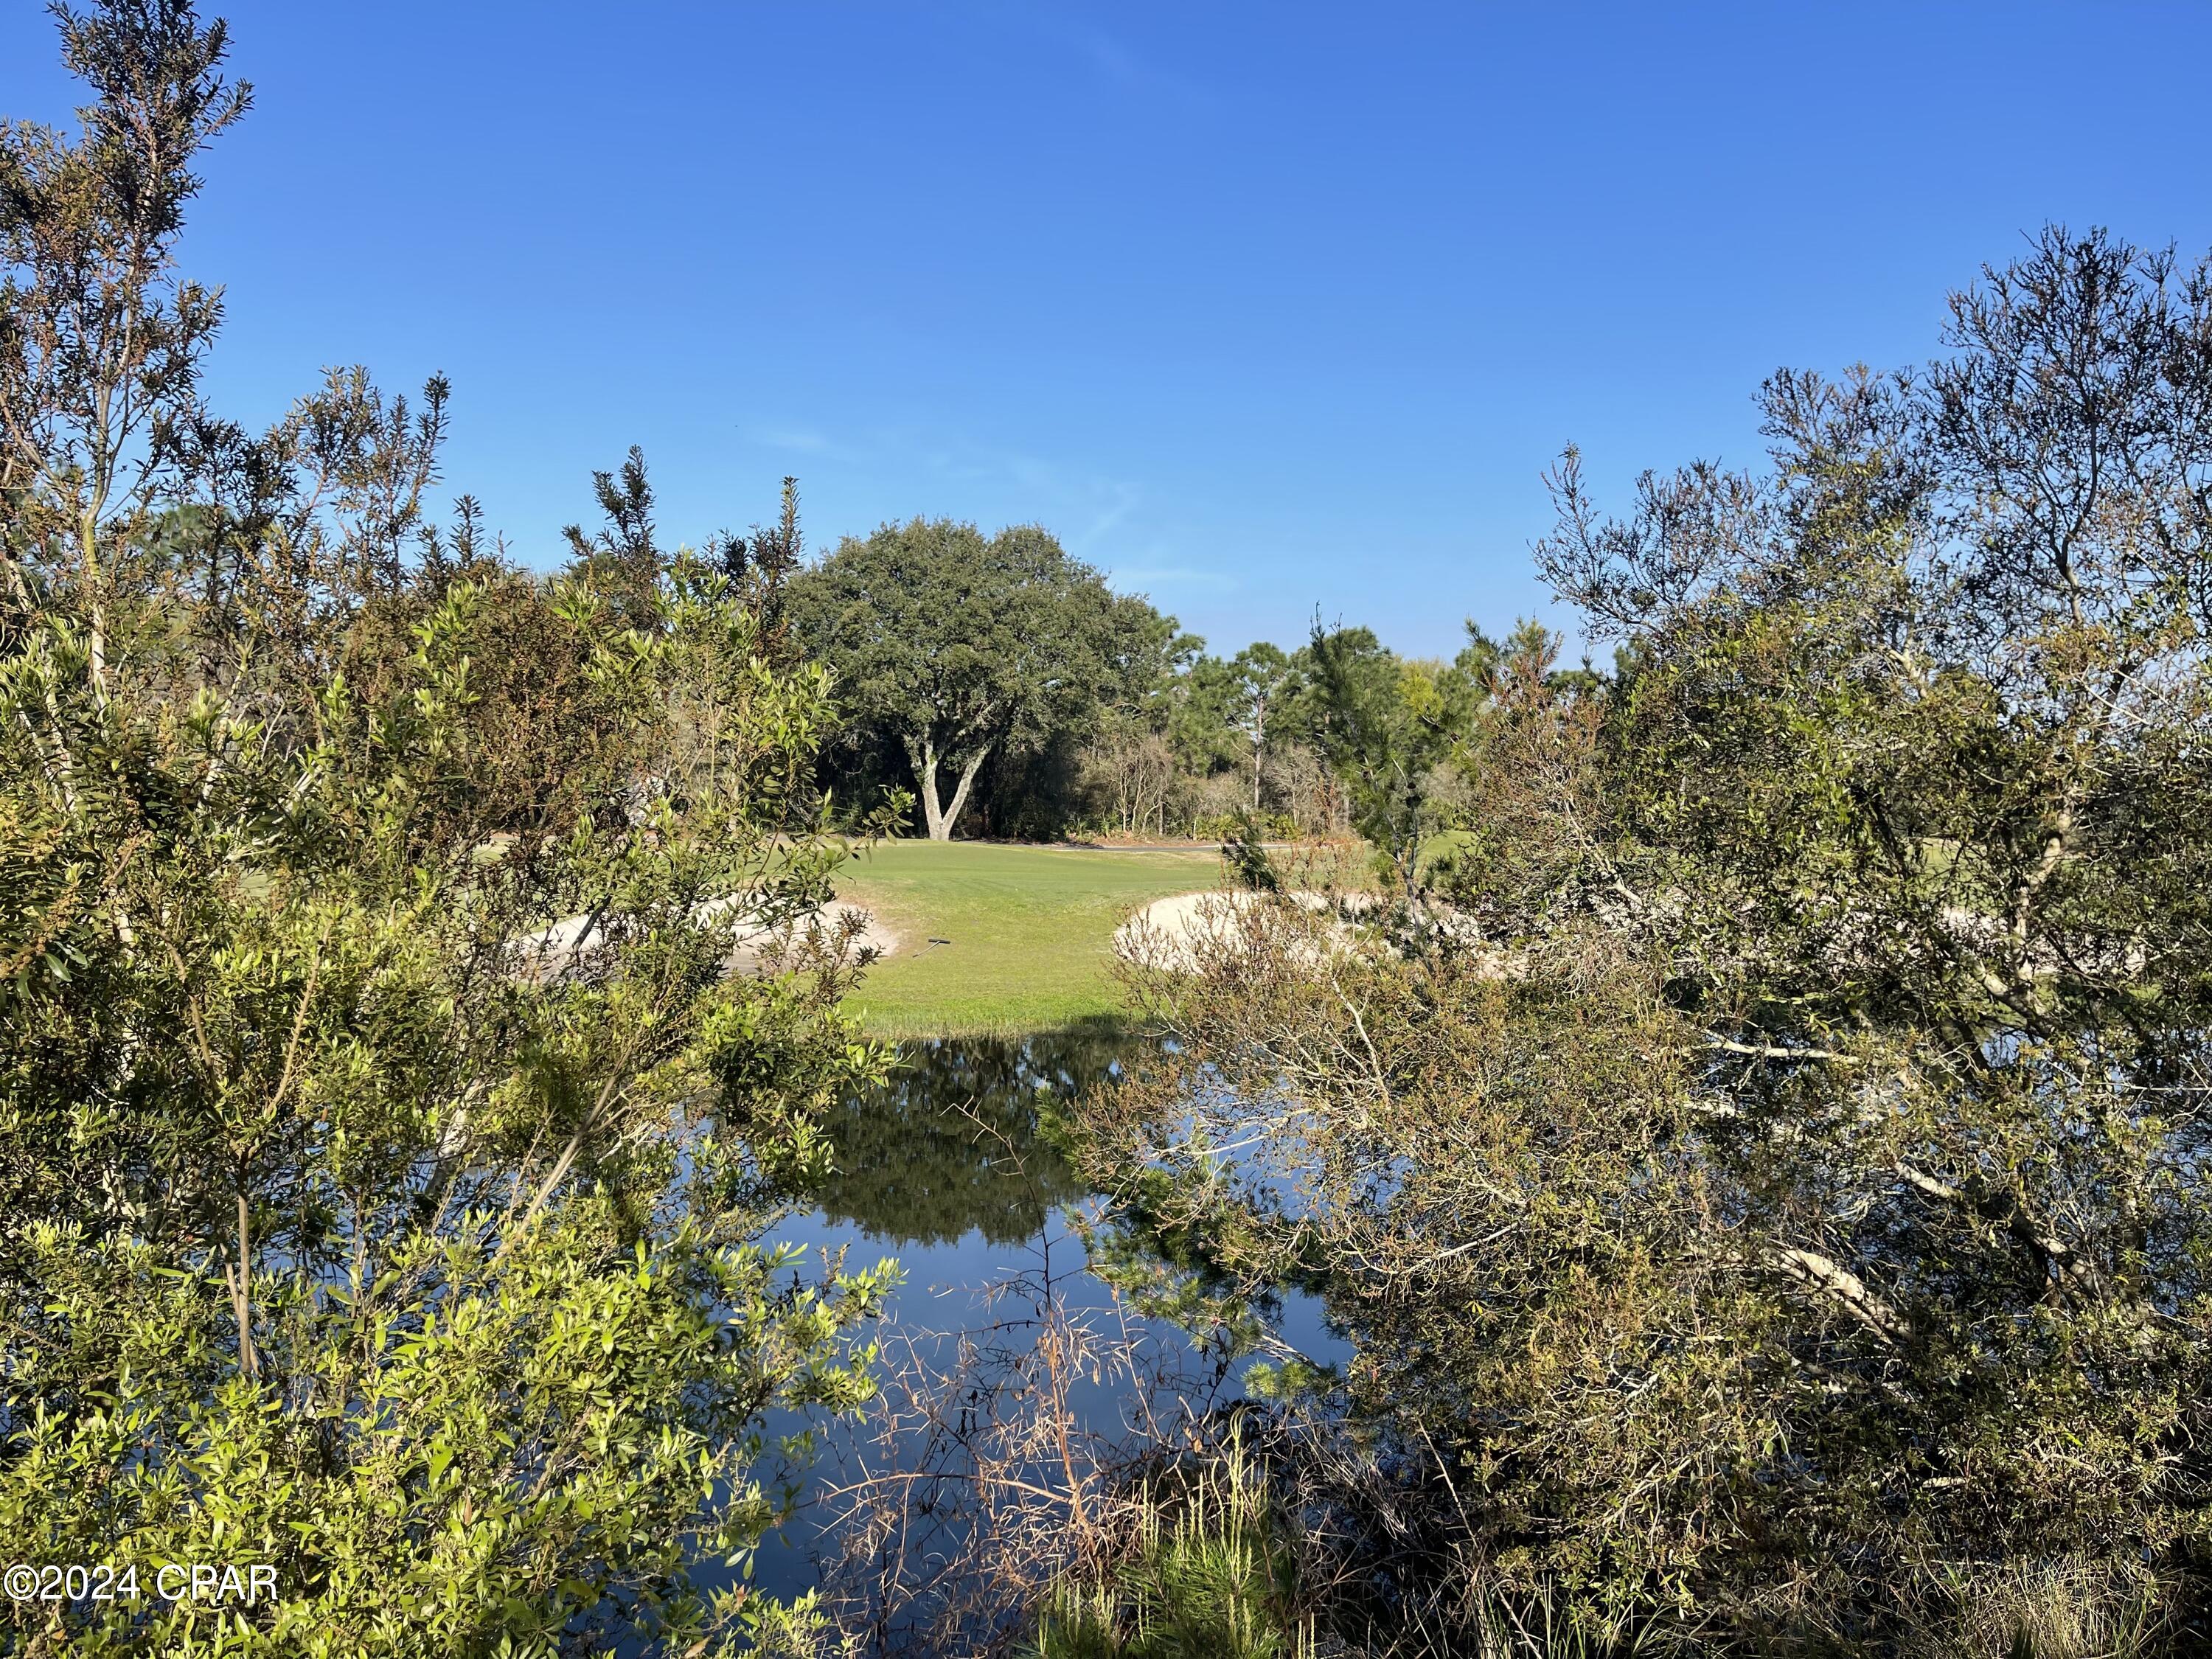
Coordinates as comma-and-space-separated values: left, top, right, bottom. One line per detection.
792, 520, 1588, 838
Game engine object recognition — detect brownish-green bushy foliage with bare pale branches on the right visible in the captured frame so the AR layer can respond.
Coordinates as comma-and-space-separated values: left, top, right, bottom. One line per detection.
1079, 230, 2212, 1646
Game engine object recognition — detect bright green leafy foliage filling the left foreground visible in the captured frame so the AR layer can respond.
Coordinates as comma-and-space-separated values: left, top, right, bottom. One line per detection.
0, 0, 885, 1655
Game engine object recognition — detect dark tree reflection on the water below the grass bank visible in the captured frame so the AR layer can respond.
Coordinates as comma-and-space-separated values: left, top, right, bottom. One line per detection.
812, 1031, 1130, 1245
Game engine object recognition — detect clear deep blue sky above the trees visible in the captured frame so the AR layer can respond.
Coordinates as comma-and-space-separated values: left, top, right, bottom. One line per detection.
0, 0, 2212, 653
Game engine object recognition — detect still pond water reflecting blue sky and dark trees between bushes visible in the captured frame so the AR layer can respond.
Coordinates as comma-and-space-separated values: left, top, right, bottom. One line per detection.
754, 1033, 1347, 1646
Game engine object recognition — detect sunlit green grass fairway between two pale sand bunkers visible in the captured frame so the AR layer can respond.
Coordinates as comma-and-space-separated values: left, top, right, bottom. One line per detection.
836, 841, 1221, 1037
